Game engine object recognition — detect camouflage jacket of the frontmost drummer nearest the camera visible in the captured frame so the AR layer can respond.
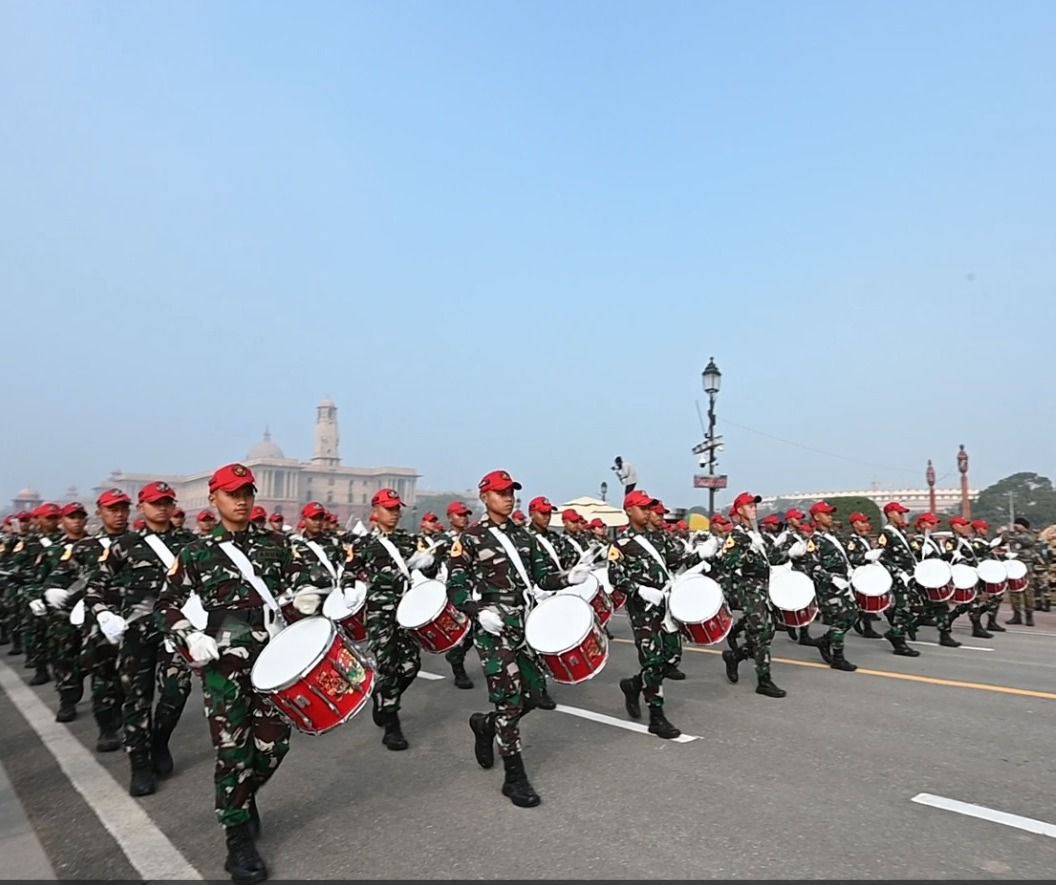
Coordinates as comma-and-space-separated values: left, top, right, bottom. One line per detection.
154, 525, 308, 645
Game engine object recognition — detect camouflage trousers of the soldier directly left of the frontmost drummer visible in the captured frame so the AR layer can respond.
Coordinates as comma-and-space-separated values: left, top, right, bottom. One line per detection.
117, 618, 191, 753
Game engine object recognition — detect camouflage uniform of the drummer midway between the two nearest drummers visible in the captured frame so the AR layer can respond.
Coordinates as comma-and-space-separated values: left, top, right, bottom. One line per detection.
343, 529, 439, 724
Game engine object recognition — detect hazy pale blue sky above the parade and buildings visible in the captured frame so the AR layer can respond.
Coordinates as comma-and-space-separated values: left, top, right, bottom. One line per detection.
0, 0, 1056, 513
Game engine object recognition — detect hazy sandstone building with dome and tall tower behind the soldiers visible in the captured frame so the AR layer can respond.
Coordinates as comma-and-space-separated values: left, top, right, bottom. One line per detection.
93, 399, 419, 525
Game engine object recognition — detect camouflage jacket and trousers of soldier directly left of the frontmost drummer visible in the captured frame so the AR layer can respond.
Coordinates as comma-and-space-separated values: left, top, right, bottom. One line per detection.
84, 529, 191, 767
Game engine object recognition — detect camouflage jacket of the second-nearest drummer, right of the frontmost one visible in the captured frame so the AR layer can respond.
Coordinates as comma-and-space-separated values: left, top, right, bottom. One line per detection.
448, 516, 567, 617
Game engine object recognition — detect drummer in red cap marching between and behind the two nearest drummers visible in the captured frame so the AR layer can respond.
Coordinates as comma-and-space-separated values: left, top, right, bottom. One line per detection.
343, 489, 439, 750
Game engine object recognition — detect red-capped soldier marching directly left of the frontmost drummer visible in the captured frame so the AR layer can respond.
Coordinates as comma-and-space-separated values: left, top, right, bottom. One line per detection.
84, 482, 191, 796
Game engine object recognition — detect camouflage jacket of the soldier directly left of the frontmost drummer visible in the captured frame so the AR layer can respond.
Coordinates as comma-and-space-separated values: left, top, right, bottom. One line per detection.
84, 529, 191, 622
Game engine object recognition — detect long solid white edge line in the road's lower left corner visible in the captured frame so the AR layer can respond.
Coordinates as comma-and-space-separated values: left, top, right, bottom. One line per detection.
0, 661, 203, 882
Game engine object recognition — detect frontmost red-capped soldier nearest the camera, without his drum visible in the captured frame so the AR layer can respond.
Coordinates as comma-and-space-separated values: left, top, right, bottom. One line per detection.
155, 464, 306, 882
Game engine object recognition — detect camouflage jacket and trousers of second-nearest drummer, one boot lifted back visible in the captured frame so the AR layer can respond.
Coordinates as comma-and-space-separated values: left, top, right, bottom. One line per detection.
448, 516, 565, 756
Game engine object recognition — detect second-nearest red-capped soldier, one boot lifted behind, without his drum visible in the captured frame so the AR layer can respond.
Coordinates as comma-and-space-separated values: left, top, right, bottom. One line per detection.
448, 470, 590, 808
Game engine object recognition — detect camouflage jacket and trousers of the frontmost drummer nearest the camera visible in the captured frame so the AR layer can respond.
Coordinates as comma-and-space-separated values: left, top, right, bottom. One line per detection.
154, 525, 306, 828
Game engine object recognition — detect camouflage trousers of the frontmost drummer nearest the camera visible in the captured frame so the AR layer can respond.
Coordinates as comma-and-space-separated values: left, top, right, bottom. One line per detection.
202, 630, 289, 827
